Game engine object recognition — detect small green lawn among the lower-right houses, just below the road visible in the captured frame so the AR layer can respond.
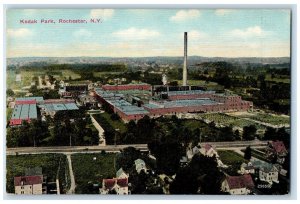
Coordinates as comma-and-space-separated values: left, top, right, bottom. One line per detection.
218, 150, 246, 176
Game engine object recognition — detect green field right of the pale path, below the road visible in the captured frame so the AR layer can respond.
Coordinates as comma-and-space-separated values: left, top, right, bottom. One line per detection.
71, 153, 116, 194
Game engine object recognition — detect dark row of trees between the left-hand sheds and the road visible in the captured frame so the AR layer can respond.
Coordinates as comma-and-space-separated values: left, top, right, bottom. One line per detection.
7, 111, 99, 147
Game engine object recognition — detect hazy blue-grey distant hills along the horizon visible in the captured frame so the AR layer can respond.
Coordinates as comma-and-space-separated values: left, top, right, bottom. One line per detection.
7, 56, 290, 66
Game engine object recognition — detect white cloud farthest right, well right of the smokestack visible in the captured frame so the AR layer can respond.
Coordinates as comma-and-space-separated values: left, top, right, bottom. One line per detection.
230, 26, 269, 38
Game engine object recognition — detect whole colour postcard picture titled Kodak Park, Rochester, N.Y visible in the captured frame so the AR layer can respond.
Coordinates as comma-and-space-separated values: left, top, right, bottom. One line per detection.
5, 8, 291, 198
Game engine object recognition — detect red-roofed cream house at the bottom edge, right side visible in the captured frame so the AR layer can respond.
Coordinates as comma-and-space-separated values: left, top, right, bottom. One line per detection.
221, 174, 254, 195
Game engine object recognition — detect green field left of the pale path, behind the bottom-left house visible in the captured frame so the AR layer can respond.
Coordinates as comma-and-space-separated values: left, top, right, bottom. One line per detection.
6, 154, 69, 193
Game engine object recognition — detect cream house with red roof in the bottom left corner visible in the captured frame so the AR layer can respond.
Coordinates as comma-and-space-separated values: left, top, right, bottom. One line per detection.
14, 175, 46, 195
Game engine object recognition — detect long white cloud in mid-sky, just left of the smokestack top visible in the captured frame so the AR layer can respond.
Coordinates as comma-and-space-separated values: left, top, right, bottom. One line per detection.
113, 27, 160, 40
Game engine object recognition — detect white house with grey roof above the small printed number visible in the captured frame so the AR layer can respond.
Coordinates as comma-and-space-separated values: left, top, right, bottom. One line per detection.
259, 163, 279, 184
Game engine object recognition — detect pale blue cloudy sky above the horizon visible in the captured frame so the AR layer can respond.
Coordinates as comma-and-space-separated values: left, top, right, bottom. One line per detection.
6, 9, 290, 57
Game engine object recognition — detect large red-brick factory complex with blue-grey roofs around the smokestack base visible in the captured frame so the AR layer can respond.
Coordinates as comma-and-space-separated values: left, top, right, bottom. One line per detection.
94, 84, 253, 122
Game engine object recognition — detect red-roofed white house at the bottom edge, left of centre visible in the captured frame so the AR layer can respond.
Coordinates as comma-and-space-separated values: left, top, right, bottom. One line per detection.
99, 178, 130, 195
